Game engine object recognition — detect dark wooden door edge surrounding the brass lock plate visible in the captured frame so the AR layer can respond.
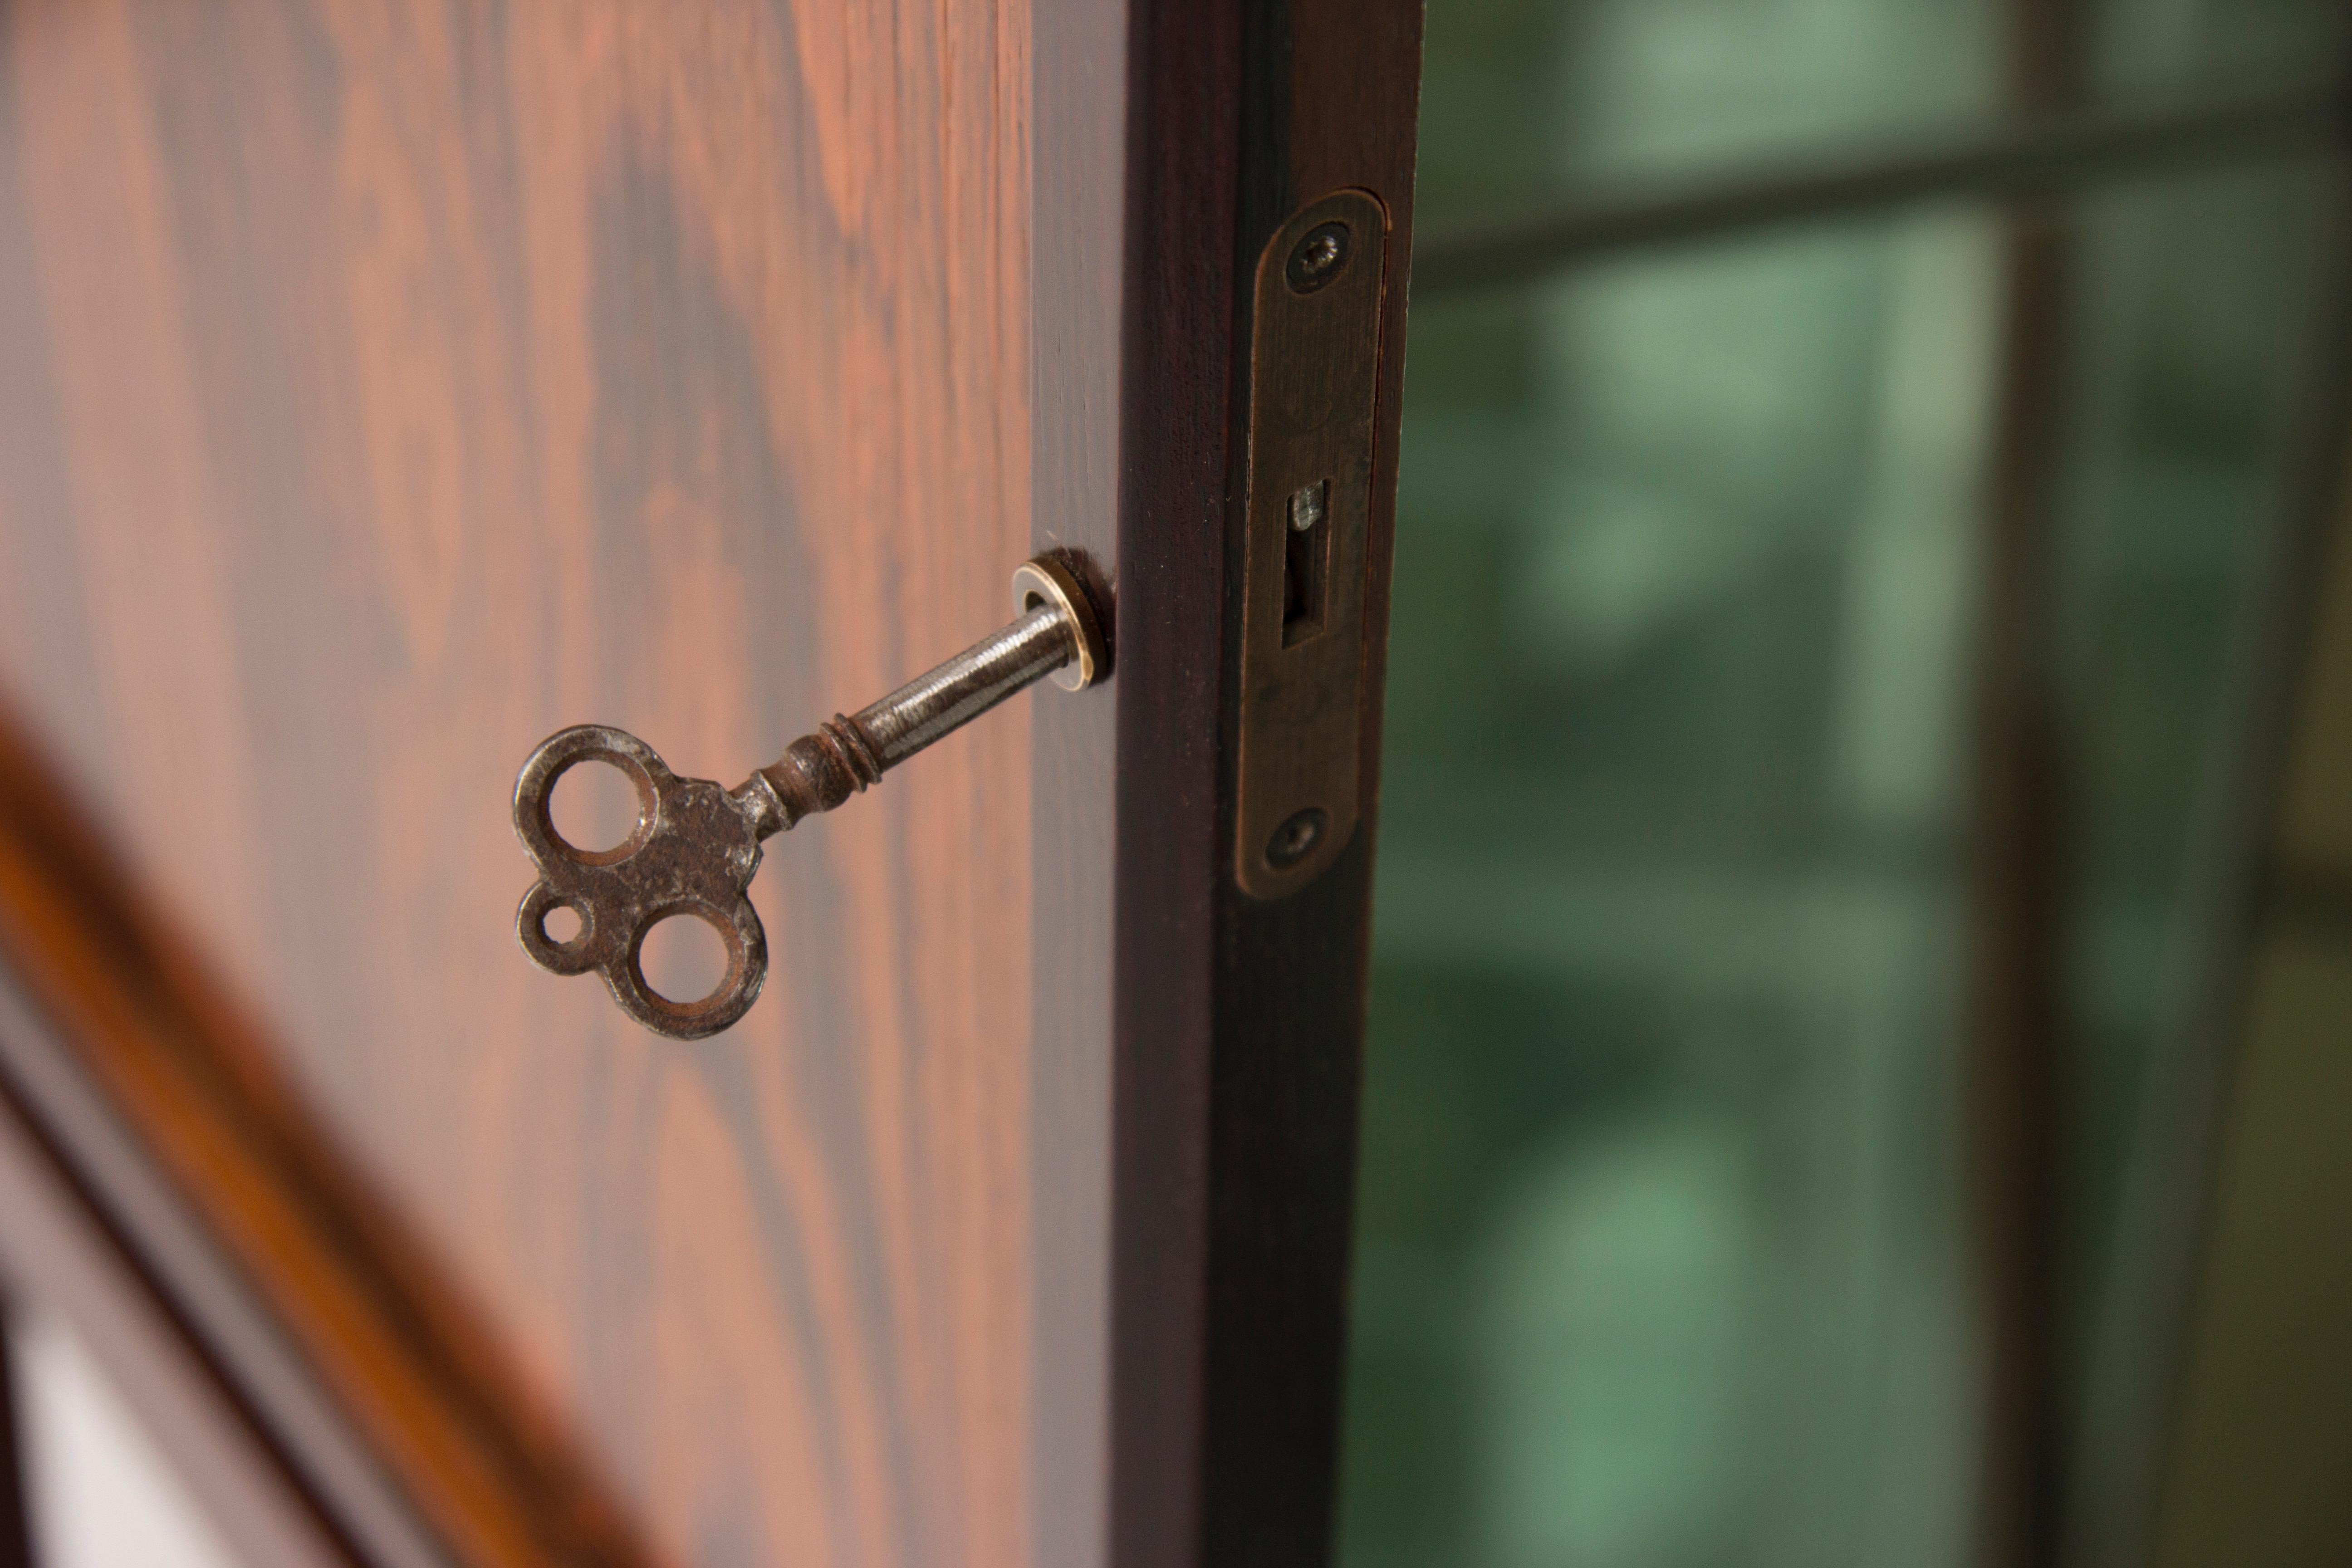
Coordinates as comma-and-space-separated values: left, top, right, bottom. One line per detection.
1110, 0, 1421, 1568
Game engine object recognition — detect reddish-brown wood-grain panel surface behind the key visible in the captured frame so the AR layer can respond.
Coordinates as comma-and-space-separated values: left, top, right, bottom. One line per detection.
0, 0, 1044, 1566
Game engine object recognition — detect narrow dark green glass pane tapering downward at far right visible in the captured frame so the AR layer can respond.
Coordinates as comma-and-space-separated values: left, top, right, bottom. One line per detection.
2060, 169, 2331, 1333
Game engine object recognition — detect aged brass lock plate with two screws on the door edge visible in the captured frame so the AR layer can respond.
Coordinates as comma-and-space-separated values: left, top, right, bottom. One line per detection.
1235, 191, 1388, 898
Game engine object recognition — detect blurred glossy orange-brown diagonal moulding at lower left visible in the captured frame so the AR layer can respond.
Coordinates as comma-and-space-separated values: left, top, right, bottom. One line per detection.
0, 715, 656, 1568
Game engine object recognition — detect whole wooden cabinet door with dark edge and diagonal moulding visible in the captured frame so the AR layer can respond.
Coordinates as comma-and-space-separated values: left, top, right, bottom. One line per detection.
0, 0, 1418, 1568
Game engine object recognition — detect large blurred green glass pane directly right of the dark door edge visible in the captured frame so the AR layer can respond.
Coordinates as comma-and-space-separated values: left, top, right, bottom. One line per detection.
1345, 219, 1994, 1568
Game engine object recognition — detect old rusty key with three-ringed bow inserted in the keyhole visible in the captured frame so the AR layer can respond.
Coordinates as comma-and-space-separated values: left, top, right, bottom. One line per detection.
515, 555, 1110, 1039
